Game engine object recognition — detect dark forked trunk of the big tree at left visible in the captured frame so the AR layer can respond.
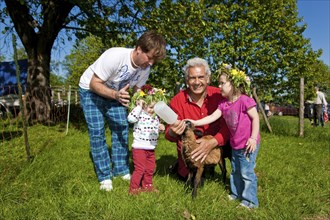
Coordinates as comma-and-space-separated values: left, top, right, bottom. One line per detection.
5, 0, 74, 122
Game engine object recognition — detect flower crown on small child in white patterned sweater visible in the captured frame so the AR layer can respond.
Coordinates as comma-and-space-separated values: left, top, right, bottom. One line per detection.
129, 84, 167, 111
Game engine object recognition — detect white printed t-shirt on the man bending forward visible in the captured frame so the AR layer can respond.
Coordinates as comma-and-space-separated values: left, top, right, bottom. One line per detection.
79, 47, 150, 91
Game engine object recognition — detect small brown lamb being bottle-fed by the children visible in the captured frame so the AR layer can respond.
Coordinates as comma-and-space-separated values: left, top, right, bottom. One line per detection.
181, 121, 227, 199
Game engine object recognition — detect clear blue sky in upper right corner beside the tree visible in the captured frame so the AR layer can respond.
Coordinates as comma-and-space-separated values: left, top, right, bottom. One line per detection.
298, 0, 330, 66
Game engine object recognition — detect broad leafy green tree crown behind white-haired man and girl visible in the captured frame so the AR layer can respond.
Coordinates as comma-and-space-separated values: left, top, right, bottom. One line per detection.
132, 0, 320, 102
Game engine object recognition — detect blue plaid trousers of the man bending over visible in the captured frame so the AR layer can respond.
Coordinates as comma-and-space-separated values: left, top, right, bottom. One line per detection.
79, 88, 129, 182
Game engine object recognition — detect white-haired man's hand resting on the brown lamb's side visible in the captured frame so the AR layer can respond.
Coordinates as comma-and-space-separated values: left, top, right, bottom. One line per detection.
191, 138, 218, 162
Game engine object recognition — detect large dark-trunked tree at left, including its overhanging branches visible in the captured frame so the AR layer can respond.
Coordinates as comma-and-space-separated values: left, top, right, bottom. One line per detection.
1, 0, 134, 122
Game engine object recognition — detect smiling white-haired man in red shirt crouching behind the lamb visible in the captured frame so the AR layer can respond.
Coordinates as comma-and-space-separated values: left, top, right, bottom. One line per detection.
165, 58, 231, 179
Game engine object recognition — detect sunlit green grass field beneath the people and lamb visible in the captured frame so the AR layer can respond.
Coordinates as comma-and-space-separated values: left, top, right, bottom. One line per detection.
0, 116, 330, 220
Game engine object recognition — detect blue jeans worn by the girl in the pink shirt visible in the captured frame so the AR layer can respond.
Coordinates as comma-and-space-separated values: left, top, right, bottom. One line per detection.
230, 144, 260, 208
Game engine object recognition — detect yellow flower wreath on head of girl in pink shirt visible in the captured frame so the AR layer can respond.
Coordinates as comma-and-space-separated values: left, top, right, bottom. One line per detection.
218, 63, 251, 95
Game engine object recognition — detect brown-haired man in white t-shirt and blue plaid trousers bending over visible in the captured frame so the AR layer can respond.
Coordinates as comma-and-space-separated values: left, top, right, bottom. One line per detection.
79, 31, 166, 191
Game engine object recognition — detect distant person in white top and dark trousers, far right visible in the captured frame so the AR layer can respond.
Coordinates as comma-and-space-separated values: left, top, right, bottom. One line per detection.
314, 86, 328, 127
